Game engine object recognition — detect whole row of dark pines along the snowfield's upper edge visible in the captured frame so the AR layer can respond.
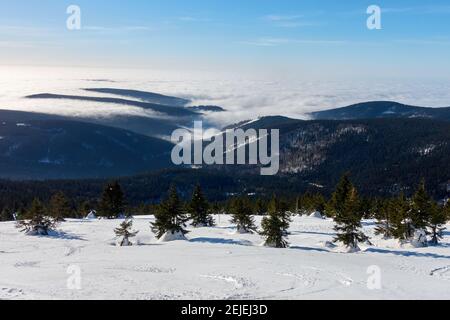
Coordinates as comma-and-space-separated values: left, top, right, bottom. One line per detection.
2, 175, 450, 248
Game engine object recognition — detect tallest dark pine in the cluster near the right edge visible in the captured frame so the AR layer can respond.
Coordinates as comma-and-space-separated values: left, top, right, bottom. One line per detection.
411, 180, 433, 230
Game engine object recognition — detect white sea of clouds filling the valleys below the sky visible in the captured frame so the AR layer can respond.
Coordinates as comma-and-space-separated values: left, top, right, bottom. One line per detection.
0, 67, 450, 127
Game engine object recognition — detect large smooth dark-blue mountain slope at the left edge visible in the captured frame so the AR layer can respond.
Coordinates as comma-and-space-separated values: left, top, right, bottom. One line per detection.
0, 110, 172, 179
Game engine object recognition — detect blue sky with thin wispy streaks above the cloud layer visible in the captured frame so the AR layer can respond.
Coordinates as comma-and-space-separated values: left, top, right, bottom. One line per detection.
0, 0, 450, 78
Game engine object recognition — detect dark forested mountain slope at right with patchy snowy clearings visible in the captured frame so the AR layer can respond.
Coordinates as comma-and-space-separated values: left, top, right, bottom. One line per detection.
215, 116, 450, 193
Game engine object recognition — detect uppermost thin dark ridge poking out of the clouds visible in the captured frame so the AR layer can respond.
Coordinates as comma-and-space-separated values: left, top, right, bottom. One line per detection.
83, 88, 191, 107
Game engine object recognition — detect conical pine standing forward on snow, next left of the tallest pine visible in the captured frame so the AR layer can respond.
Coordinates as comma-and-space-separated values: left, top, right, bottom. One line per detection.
261, 196, 289, 248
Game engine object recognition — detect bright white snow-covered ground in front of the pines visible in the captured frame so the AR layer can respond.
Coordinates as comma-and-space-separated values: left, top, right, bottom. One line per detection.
0, 216, 450, 299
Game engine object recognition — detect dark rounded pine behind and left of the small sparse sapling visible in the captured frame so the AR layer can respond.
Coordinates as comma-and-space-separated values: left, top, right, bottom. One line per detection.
98, 181, 125, 219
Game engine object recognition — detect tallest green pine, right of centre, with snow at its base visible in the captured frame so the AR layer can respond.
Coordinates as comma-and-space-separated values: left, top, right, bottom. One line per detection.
328, 175, 368, 251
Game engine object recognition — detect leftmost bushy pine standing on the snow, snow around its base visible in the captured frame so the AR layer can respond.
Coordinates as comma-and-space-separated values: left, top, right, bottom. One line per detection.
17, 199, 56, 236
